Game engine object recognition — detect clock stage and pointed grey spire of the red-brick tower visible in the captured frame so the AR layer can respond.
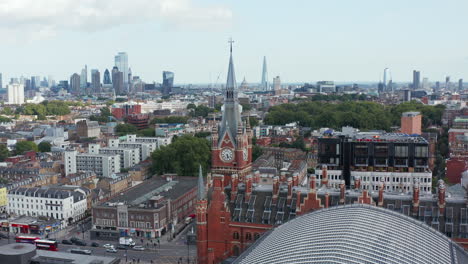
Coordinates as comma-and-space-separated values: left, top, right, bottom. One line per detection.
211, 40, 252, 186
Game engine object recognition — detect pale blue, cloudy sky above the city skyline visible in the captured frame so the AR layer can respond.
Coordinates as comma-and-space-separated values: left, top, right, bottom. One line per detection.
0, 0, 468, 85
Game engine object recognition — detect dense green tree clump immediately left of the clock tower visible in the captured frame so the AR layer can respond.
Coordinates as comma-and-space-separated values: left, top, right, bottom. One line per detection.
151, 135, 211, 176
